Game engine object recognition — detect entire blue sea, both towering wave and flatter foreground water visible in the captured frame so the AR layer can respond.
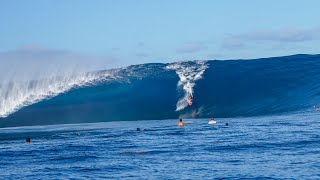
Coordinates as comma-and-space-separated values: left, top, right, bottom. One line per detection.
0, 54, 320, 179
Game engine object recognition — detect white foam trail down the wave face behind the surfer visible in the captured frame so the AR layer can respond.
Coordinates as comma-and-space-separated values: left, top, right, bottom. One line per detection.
166, 61, 208, 111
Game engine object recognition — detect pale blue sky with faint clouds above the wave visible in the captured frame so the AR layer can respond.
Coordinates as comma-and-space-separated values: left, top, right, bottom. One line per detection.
0, 0, 320, 70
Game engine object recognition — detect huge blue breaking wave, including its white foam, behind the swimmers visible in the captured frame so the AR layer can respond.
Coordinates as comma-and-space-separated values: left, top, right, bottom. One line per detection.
0, 55, 320, 127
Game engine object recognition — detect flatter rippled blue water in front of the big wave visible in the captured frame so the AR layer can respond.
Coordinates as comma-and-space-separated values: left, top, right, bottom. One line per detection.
0, 111, 320, 179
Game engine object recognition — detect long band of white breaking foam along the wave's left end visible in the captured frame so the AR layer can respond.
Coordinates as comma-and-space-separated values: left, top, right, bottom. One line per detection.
0, 72, 115, 118
